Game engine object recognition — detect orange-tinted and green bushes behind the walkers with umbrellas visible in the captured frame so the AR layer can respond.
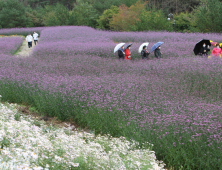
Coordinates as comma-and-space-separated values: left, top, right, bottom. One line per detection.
109, 1, 173, 31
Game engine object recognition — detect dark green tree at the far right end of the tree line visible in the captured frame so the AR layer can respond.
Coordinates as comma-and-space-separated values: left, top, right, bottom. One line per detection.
195, 0, 222, 32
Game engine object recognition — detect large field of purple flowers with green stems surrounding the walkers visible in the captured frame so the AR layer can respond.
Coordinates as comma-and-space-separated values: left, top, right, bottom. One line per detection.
0, 26, 222, 169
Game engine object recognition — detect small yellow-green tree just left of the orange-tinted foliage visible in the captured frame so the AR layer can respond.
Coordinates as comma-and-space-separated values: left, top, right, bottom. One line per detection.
97, 6, 119, 30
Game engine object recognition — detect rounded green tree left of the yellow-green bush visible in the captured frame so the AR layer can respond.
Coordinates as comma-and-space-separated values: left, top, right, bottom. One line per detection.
69, 0, 98, 27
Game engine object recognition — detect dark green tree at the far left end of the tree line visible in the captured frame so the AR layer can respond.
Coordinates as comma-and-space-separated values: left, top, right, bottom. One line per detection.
0, 0, 30, 28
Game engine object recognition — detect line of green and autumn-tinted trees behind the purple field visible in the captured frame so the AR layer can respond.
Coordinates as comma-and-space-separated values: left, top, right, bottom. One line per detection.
0, 0, 222, 32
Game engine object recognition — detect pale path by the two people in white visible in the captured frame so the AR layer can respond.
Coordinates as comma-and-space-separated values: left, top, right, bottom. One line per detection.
15, 39, 38, 58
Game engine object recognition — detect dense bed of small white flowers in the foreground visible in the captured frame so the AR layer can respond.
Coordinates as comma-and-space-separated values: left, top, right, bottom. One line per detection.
0, 103, 164, 170
